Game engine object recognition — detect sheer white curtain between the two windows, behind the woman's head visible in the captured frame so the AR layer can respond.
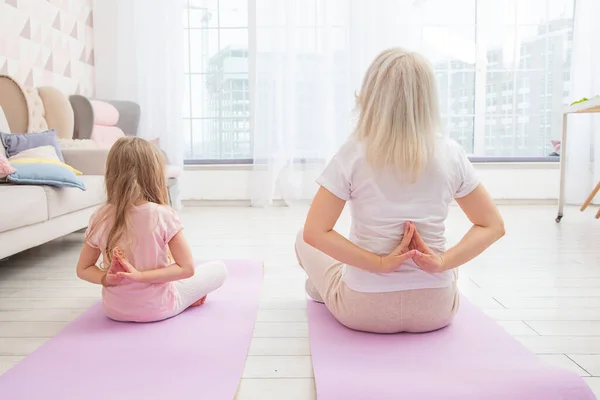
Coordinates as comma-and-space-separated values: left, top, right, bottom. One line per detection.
250, 0, 450, 206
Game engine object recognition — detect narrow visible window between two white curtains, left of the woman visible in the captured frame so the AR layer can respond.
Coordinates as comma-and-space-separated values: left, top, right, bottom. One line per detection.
183, 0, 252, 162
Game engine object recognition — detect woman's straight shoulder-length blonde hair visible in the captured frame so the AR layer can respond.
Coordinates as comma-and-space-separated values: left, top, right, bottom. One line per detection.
355, 48, 441, 182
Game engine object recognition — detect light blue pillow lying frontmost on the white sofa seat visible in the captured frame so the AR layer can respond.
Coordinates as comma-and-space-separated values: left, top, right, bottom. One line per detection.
6, 163, 85, 190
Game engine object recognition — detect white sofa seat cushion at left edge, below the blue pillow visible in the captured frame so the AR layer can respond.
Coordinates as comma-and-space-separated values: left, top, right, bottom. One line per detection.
0, 183, 47, 232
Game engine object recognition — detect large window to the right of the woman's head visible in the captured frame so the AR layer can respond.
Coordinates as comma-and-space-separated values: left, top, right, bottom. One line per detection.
421, 0, 574, 158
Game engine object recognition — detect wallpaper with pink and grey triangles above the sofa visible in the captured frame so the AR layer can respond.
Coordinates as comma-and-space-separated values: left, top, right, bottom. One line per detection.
0, 0, 94, 96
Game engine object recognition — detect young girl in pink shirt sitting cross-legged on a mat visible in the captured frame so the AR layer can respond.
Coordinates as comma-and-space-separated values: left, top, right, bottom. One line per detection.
77, 137, 227, 322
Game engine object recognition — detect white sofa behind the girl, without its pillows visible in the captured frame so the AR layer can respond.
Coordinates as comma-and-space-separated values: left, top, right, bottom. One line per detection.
0, 149, 108, 259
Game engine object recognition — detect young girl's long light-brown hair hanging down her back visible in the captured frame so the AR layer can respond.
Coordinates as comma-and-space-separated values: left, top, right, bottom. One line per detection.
89, 137, 169, 265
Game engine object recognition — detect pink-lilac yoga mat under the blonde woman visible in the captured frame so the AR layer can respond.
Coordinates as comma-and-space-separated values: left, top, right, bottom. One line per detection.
308, 298, 596, 400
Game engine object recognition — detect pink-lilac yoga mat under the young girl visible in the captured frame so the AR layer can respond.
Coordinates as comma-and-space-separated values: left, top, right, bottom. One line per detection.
0, 261, 262, 400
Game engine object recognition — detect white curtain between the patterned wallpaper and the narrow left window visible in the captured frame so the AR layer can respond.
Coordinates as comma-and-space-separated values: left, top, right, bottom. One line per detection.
94, 0, 184, 208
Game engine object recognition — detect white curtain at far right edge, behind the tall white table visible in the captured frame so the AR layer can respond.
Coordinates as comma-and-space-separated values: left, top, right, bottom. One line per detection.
565, 0, 600, 204
